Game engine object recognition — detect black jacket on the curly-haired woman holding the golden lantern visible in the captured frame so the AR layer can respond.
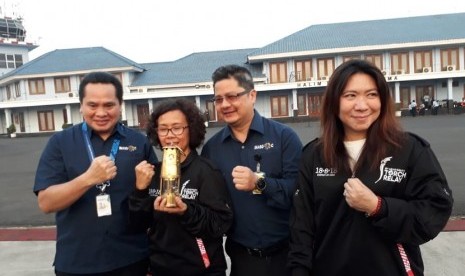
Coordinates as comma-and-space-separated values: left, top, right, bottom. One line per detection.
129, 151, 233, 276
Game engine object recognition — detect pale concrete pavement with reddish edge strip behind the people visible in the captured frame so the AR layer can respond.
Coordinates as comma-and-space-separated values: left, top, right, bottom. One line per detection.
0, 218, 465, 276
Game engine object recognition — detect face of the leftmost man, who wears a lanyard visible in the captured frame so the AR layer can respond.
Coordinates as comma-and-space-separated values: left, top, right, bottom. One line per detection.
81, 83, 121, 140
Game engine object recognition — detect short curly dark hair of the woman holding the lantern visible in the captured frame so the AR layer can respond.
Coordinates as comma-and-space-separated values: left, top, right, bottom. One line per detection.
146, 98, 207, 150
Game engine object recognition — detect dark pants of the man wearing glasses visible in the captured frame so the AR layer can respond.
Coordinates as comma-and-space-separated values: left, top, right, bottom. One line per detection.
226, 239, 291, 276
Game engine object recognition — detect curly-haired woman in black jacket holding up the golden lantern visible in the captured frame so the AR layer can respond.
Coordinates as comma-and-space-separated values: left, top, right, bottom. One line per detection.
129, 99, 233, 276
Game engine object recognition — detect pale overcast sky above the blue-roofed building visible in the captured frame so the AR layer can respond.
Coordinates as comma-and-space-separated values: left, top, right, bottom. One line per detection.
0, 0, 465, 63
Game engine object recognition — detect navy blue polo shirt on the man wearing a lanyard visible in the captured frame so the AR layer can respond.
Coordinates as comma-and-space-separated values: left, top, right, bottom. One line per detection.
34, 124, 157, 274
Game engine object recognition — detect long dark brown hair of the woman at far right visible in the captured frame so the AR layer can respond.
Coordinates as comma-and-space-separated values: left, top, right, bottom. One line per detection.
320, 60, 405, 172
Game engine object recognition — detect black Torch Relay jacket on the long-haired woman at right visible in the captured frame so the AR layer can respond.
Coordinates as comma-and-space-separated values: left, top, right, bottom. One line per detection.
289, 134, 453, 276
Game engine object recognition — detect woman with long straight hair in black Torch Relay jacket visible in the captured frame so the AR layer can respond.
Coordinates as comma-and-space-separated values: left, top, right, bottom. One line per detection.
289, 60, 453, 276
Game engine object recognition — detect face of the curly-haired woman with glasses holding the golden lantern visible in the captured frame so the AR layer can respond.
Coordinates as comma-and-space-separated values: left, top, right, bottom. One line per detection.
157, 110, 190, 158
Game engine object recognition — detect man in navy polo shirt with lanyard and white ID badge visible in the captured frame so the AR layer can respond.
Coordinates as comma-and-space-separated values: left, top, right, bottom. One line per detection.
34, 72, 157, 276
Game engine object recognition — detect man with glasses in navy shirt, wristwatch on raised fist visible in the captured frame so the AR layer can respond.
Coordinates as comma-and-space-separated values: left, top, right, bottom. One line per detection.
202, 65, 302, 276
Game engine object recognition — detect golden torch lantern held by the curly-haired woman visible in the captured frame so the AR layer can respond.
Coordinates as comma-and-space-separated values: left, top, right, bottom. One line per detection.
160, 146, 184, 207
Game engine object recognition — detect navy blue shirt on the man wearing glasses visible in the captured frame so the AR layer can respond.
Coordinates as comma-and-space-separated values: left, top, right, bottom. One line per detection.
202, 111, 302, 248
